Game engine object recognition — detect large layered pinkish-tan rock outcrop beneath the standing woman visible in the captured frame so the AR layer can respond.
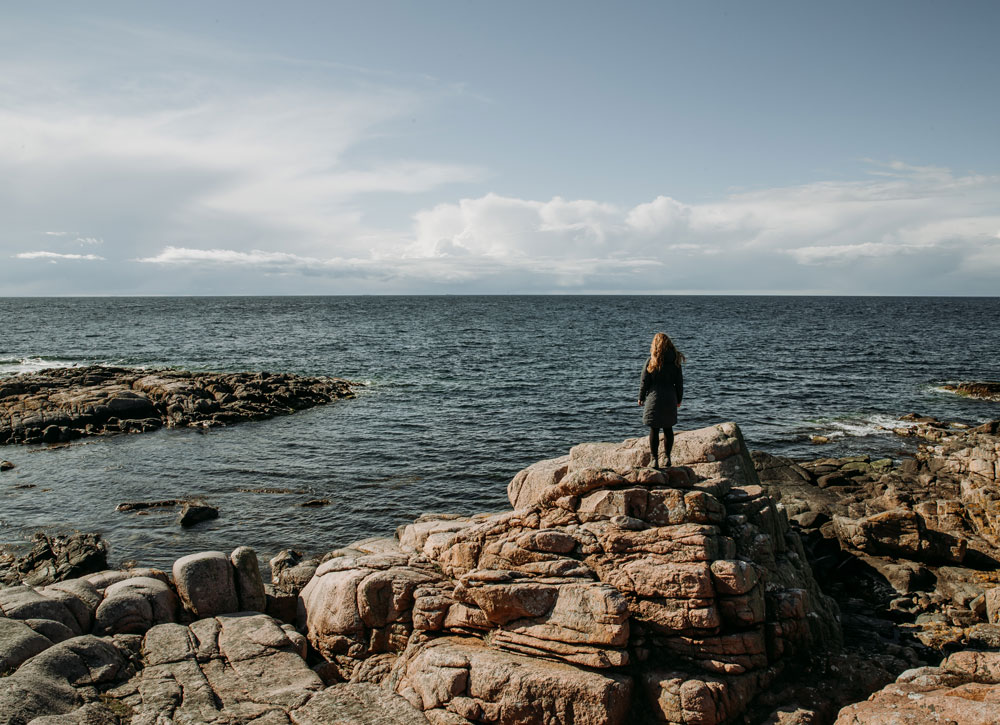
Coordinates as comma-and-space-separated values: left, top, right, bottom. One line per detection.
286, 424, 840, 725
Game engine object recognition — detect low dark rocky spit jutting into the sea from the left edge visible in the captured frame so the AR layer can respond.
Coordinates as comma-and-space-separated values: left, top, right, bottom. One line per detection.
0, 366, 354, 444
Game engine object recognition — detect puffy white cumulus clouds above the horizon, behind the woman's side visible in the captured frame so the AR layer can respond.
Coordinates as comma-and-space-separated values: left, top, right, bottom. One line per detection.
394, 163, 1000, 292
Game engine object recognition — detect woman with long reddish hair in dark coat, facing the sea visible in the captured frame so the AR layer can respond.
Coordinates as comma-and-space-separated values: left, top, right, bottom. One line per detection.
639, 332, 684, 468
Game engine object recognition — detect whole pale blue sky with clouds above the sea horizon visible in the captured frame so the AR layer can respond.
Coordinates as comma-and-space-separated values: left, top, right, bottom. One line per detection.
0, 0, 1000, 296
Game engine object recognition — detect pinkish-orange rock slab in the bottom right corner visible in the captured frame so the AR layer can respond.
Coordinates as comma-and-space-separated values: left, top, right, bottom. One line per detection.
836, 651, 1000, 725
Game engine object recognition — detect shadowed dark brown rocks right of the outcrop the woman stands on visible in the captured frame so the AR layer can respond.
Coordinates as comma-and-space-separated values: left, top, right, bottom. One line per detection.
753, 415, 1000, 661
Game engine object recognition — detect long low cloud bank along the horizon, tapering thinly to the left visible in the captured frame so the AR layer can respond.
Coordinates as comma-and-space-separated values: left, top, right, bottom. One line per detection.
121, 163, 1000, 294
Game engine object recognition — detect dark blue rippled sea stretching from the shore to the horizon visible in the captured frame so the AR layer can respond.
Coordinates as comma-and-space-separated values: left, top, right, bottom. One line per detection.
0, 297, 1000, 566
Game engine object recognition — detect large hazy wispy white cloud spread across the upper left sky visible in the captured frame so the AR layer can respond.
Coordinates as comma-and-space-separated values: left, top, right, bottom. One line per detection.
0, 17, 487, 268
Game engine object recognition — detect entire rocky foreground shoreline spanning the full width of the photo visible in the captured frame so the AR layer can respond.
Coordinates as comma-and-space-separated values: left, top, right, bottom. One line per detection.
0, 419, 1000, 725
